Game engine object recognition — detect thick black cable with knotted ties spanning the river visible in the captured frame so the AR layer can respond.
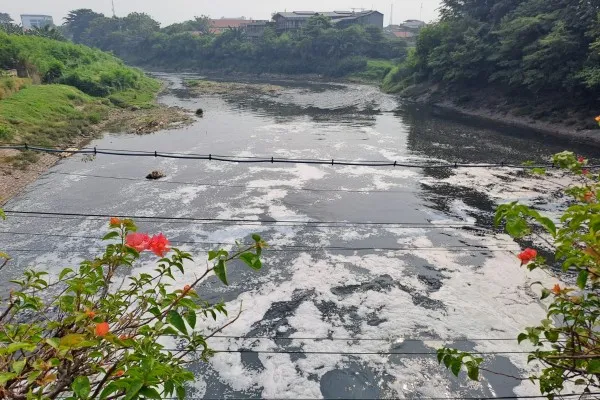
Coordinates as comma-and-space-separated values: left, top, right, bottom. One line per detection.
0, 144, 576, 169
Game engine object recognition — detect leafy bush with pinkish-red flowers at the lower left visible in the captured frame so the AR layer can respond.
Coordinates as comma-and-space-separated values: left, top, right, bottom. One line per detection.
0, 215, 265, 400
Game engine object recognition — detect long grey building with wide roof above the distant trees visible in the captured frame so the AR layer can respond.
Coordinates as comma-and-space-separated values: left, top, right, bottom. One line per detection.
273, 10, 383, 32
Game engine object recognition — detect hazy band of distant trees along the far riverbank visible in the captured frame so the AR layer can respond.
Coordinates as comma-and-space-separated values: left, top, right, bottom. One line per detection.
59, 9, 406, 79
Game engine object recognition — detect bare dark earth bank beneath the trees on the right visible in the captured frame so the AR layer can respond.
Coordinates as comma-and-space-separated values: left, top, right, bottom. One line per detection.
400, 85, 600, 148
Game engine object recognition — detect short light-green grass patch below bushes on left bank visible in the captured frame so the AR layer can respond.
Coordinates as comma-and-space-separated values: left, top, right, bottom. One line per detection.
0, 85, 109, 146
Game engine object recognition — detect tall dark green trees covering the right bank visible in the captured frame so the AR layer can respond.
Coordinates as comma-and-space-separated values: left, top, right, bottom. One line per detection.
385, 0, 600, 125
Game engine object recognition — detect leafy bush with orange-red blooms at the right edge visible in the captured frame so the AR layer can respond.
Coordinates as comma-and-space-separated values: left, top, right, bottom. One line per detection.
438, 152, 600, 398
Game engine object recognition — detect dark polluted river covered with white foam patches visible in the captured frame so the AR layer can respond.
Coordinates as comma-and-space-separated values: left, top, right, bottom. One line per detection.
0, 74, 593, 399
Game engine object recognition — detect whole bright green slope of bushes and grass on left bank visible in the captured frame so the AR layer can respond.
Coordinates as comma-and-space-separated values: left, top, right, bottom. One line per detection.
0, 31, 160, 149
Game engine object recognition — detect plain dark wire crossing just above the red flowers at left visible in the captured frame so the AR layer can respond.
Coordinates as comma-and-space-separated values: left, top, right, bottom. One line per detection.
4, 210, 486, 230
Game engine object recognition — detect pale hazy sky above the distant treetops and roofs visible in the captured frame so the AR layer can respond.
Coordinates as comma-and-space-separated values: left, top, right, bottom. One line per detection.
0, 0, 440, 26
